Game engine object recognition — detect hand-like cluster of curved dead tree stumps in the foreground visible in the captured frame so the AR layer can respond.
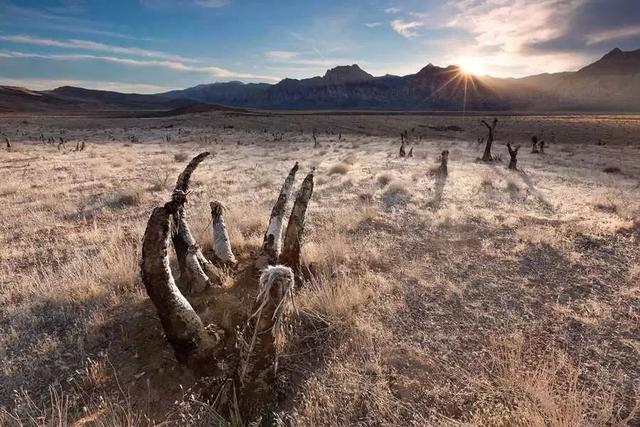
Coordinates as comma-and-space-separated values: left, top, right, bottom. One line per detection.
140, 152, 314, 418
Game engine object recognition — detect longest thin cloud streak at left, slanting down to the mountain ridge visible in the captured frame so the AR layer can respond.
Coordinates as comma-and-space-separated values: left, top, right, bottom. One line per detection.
0, 51, 280, 81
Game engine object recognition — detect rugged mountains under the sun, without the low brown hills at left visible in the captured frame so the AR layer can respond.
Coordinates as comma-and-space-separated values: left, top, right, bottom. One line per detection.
163, 49, 640, 111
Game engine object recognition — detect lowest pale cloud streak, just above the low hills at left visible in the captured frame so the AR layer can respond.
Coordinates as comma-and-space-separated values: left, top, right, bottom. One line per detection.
0, 76, 176, 93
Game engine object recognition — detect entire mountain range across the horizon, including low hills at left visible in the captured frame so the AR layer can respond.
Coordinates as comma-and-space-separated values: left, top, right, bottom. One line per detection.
0, 49, 640, 114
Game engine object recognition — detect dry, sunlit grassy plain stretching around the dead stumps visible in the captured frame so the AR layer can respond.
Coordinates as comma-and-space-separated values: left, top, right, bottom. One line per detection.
0, 113, 640, 427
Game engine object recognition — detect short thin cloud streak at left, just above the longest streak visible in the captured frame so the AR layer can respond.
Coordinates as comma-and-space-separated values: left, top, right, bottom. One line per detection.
0, 35, 192, 62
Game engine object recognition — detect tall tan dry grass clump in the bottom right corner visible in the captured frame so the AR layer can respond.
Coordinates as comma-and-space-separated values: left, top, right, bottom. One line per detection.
470, 333, 640, 427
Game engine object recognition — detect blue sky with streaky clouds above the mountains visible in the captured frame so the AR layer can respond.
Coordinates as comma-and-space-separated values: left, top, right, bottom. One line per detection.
0, 0, 640, 93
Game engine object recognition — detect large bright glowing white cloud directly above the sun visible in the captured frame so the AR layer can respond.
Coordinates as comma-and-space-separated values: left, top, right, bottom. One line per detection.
446, 0, 592, 77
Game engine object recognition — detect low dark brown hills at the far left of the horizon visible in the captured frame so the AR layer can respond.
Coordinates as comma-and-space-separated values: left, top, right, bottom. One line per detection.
0, 86, 200, 112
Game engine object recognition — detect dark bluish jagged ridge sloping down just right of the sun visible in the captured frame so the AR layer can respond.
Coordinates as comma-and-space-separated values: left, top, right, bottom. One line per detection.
162, 64, 509, 110
